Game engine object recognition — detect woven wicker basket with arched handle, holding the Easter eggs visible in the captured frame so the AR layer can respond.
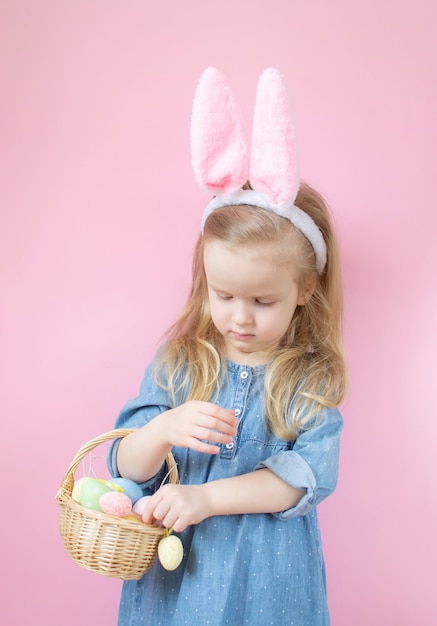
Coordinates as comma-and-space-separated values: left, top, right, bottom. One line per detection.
56, 429, 179, 580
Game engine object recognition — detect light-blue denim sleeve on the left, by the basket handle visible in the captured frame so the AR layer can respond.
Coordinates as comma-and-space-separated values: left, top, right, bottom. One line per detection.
107, 363, 172, 488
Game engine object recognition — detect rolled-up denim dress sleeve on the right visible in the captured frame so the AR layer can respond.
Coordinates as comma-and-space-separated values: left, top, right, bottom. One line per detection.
255, 408, 343, 519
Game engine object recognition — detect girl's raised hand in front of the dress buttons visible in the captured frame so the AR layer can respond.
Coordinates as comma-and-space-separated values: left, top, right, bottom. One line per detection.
160, 401, 238, 454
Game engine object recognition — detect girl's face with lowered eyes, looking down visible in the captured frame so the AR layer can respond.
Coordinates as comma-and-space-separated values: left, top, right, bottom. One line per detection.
203, 239, 305, 365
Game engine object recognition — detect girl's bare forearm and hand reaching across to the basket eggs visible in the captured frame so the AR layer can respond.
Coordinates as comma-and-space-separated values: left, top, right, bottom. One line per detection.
143, 468, 305, 532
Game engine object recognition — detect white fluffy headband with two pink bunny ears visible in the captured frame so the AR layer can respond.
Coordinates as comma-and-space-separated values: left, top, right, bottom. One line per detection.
191, 67, 326, 274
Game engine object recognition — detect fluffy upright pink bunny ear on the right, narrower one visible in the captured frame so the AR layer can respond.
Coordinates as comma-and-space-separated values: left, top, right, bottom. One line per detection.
250, 68, 299, 206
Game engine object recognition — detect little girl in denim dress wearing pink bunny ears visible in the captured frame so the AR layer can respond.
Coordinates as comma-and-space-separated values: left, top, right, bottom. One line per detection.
109, 68, 346, 626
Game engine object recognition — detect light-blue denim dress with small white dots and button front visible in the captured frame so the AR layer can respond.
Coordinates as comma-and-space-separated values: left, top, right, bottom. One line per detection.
108, 361, 343, 626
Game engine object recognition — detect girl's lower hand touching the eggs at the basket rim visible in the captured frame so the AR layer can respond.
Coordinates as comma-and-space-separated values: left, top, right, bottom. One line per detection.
142, 485, 211, 532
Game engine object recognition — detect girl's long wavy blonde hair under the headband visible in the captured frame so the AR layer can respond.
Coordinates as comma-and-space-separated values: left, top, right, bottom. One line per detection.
156, 183, 346, 440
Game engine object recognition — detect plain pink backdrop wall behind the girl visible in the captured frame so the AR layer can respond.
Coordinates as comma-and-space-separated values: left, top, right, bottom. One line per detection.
0, 0, 437, 626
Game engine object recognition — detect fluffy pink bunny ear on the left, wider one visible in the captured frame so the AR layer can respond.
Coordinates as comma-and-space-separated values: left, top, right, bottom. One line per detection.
191, 67, 249, 194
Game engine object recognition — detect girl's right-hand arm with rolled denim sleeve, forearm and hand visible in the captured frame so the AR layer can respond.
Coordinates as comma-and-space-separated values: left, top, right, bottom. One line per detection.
138, 409, 343, 532
